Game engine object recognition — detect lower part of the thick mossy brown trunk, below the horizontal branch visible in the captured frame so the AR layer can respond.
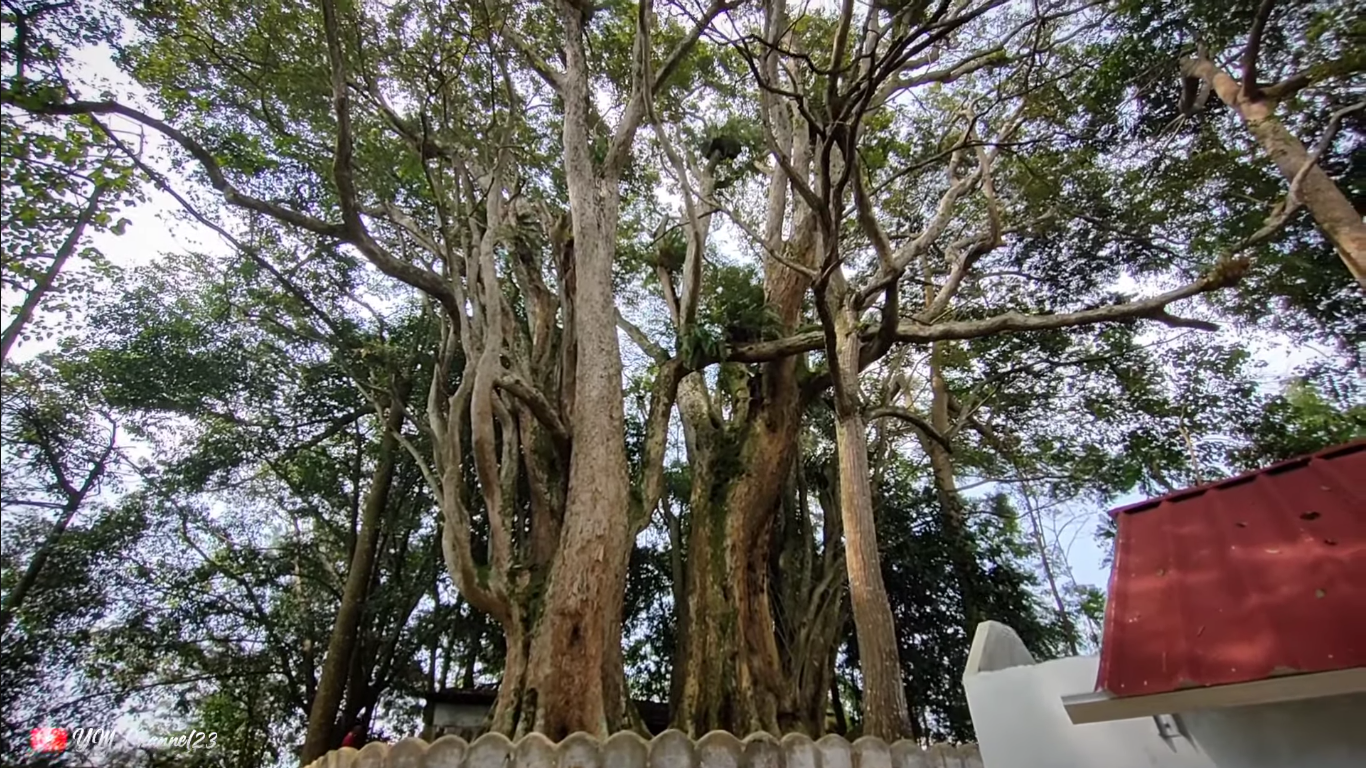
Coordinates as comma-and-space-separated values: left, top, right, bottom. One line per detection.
673, 349, 833, 737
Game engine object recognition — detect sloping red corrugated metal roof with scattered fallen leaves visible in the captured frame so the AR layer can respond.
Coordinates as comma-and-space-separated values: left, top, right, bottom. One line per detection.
1096, 440, 1366, 697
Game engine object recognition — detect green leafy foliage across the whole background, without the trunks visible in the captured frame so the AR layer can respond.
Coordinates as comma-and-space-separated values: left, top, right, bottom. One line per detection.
0, 0, 1366, 748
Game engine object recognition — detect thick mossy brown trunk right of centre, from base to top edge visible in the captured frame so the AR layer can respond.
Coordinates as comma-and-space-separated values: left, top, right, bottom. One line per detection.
672, 3, 833, 737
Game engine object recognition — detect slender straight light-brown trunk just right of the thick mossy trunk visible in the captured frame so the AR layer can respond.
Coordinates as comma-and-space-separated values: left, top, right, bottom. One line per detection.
817, 297, 911, 742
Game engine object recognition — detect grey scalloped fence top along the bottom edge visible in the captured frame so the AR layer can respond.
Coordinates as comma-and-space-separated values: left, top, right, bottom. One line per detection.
309, 731, 984, 768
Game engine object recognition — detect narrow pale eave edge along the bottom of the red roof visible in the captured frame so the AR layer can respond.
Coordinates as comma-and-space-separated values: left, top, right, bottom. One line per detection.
1063, 667, 1366, 726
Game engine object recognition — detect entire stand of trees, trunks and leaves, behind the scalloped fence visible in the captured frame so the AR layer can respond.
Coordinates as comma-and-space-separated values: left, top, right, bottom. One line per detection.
0, 0, 1366, 767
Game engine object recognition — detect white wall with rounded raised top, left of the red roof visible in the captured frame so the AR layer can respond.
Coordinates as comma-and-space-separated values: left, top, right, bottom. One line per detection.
963, 622, 1218, 768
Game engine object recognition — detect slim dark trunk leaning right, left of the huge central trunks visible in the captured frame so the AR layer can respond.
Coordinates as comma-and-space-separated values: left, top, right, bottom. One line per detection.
301, 385, 406, 765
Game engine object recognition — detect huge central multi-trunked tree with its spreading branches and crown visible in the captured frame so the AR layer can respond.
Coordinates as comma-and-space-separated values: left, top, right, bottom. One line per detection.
3, 0, 1361, 760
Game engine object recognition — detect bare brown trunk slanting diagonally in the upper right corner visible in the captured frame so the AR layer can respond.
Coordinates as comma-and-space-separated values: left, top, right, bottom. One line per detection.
1182, 59, 1366, 288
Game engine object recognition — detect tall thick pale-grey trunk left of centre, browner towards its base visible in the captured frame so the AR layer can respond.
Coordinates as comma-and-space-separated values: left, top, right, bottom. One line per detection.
519, 3, 631, 739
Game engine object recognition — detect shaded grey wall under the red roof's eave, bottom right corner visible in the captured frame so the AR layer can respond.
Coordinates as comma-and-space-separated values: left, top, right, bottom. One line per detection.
1185, 693, 1366, 768
